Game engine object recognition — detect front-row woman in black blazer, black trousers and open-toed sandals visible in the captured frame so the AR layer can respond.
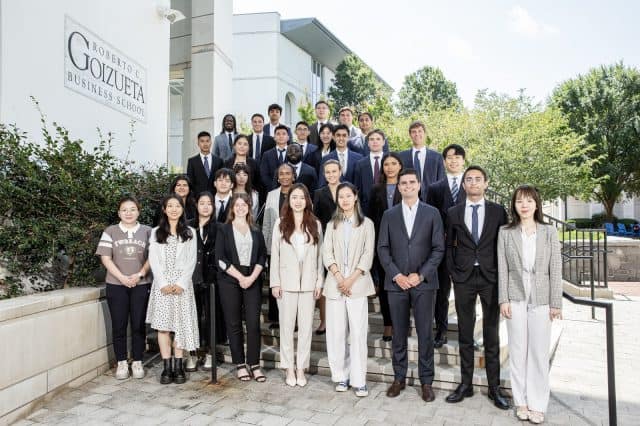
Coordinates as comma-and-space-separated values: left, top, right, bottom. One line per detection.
215, 193, 267, 382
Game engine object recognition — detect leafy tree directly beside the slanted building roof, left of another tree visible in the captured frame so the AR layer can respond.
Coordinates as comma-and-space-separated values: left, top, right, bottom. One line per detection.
328, 54, 391, 112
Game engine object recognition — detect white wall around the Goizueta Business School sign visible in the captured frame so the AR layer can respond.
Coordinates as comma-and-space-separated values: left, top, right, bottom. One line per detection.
0, 0, 169, 164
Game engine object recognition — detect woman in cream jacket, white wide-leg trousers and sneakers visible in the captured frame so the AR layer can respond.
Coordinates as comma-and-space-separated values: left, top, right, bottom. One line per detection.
322, 182, 375, 397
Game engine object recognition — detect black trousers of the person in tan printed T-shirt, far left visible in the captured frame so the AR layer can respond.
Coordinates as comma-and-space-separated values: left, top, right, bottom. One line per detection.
107, 284, 151, 361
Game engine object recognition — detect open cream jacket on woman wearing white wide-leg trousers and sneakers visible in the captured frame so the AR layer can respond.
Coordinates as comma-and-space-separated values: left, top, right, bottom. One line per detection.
322, 217, 376, 299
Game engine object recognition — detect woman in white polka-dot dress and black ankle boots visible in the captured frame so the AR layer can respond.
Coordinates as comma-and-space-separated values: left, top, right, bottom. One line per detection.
146, 194, 200, 384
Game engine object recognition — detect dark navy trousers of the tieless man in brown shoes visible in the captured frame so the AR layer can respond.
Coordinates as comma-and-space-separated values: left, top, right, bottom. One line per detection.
387, 284, 436, 385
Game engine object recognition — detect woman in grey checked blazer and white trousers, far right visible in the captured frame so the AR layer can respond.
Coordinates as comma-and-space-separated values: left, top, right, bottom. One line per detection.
498, 185, 562, 424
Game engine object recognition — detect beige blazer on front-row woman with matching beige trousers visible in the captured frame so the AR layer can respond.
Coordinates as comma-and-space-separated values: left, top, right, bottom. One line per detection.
269, 219, 324, 292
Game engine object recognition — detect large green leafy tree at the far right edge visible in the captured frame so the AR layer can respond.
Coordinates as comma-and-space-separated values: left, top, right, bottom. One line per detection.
551, 63, 640, 219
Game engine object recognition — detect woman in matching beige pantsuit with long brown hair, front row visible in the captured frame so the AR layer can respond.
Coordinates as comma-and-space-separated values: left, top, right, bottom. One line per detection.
269, 183, 324, 386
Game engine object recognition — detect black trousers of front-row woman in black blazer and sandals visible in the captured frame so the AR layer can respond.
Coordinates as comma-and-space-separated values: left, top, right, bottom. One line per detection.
218, 266, 262, 365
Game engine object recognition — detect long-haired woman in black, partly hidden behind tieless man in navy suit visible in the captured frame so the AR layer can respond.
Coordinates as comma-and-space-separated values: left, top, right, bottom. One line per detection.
367, 152, 402, 342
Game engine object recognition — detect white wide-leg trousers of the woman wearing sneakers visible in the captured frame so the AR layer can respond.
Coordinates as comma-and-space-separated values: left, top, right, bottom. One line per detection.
326, 296, 369, 388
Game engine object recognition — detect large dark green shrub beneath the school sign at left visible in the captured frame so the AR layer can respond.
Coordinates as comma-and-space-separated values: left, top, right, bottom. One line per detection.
0, 116, 170, 297
